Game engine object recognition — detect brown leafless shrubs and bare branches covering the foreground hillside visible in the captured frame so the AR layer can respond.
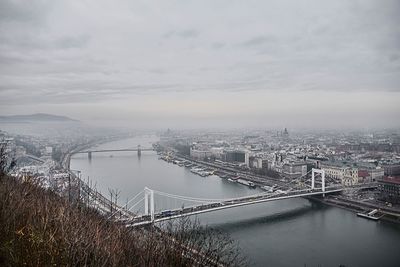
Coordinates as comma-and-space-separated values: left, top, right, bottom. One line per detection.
0, 146, 244, 266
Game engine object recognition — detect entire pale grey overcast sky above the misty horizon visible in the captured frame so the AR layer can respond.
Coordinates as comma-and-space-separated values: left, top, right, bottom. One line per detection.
0, 0, 400, 130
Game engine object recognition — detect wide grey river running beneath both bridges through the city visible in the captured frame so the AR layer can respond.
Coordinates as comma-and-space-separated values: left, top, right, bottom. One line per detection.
71, 136, 400, 267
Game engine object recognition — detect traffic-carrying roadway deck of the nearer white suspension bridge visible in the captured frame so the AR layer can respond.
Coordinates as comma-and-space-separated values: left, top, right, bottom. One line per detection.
125, 183, 376, 227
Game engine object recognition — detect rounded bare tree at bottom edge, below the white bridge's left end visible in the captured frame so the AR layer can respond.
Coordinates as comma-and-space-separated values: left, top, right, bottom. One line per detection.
139, 217, 247, 266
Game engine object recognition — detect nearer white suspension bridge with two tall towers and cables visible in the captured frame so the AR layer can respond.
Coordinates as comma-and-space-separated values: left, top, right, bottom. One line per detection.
104, 169, 376, 227
